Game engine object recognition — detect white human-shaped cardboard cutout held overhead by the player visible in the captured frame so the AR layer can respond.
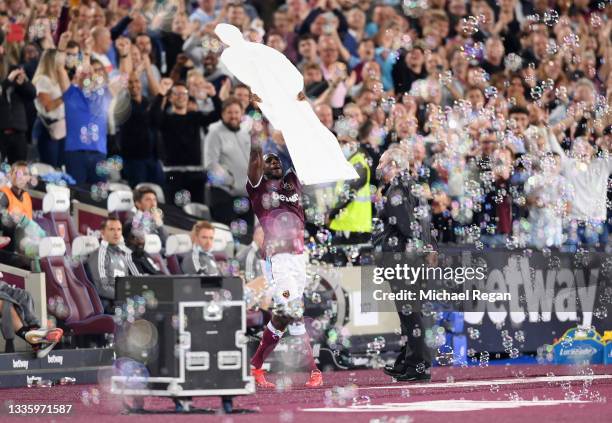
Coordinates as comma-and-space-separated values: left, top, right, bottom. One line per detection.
215, 24, 358, 185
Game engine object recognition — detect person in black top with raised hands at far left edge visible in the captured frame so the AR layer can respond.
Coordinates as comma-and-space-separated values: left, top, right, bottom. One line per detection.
0, 67, 36, 163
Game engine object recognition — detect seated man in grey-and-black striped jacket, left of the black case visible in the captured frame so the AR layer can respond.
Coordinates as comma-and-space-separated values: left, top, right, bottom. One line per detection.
87, 217, 140, 314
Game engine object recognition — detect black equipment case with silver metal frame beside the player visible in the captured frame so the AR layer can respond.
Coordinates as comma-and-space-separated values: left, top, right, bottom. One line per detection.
111, 276, 255, 402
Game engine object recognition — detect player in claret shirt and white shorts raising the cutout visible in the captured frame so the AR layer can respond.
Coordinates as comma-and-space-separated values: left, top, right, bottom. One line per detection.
246, 96, 323, 388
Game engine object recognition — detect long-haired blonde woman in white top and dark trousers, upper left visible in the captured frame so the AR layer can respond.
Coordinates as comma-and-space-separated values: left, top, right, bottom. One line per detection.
32, 49, 66, 167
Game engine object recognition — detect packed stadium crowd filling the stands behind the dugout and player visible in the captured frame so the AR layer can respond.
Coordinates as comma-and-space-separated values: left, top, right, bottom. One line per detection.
0, 0, 612, 262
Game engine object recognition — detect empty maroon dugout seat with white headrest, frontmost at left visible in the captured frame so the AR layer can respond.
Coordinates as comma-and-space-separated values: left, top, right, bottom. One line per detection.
39, 237, 115, 335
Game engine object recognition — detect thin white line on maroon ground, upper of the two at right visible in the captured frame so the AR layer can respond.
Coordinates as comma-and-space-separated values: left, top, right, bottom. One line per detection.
359, 375, 612, 389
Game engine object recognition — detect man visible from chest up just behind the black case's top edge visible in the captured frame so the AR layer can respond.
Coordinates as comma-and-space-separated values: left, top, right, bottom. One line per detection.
181, 221, 221, 276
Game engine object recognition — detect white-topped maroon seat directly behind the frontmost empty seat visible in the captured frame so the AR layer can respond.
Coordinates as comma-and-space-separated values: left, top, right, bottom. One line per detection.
41, 189, 79, 255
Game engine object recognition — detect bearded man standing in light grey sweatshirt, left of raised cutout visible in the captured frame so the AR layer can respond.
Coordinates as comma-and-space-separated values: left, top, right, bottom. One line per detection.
204, 98, 253, 230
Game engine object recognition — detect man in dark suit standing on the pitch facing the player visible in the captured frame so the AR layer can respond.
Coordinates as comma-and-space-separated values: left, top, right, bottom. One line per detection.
373, 147, 435, 381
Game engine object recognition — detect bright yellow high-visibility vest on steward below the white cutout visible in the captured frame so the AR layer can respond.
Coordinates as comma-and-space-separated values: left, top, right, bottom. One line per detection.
329, 152, 372, 232
